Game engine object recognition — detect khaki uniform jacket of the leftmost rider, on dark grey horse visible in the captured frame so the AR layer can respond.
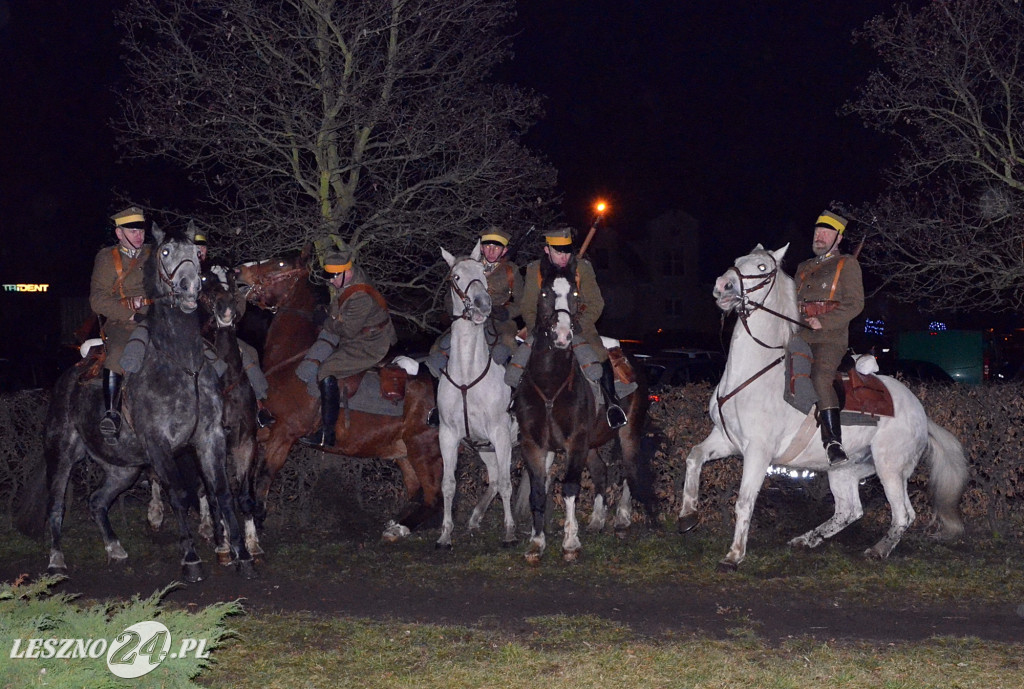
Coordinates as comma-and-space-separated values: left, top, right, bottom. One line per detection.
89, 245, 150, 374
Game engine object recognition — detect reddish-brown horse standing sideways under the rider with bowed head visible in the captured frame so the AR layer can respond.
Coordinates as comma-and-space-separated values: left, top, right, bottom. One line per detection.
236, 253, 443, 541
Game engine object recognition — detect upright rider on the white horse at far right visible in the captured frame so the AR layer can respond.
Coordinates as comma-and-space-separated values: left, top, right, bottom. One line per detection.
797, 211, 864, 467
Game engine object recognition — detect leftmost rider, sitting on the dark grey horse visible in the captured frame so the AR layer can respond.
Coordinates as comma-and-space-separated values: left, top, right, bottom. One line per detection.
89, 206, 152, 438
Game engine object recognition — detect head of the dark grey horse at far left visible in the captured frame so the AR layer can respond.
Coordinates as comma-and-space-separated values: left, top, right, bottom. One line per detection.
145, 222, 203, 313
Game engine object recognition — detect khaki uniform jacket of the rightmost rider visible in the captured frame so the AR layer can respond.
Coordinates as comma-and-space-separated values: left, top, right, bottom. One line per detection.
797, 254, 864, 348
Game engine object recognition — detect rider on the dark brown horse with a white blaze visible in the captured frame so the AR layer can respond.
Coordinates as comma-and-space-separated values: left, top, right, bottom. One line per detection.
505, 225, 627, 428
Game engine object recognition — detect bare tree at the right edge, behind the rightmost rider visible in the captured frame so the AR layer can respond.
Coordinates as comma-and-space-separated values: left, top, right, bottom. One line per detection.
845, 0, 1024, 311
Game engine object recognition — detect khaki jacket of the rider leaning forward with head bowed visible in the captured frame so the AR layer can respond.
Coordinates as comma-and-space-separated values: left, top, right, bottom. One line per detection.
317, 268, 398, 380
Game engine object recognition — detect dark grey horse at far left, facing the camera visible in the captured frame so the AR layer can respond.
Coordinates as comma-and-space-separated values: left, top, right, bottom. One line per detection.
44, 225, 255, 582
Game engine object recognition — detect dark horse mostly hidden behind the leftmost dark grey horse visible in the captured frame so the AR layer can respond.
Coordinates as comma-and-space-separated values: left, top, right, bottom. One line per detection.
146, 265, 264, 559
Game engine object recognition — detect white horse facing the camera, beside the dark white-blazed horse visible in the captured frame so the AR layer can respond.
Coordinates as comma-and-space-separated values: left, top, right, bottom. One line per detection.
436, 242, 517, 548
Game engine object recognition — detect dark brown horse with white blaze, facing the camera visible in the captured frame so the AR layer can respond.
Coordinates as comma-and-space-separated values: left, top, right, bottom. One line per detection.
514, 258, 657, 564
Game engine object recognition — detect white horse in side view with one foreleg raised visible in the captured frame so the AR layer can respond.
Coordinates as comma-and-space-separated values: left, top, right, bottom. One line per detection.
679, 245, 968, 569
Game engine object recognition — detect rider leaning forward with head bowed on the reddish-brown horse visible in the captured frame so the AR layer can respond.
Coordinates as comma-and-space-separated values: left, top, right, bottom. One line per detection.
295, 239, 398, 447
